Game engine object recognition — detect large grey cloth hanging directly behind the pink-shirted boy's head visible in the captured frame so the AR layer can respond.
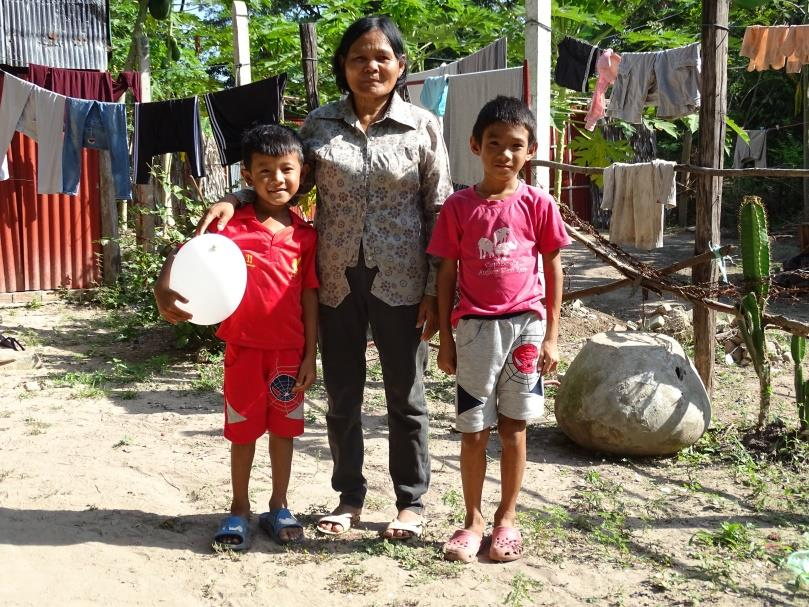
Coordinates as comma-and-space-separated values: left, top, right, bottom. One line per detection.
444, 67, 523, 185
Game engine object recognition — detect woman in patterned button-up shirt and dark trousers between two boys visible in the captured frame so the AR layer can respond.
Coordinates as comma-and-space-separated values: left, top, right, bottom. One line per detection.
198, 16, 452, 539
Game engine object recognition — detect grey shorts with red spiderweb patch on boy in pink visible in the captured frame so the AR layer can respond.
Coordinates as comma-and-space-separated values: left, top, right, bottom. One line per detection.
455, 312, 545, 432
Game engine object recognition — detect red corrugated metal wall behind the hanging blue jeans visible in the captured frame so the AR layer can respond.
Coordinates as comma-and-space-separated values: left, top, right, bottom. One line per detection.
0, 133, 101, 293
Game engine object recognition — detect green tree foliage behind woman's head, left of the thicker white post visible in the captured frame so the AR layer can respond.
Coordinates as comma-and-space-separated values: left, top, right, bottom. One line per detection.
110, 0, 524, 114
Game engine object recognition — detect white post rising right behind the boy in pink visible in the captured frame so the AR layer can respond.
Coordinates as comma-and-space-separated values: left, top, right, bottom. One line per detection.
525, 0, 561, 189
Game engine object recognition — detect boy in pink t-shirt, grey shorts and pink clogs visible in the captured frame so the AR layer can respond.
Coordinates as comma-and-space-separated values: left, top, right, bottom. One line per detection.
427, 96, 570, 562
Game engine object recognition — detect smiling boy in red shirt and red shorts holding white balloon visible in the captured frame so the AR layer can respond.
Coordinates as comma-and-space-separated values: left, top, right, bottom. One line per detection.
154, 125, 318, 551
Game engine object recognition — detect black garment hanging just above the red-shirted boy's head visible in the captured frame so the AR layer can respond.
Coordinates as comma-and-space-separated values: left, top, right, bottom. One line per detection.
205, 74, 287, 165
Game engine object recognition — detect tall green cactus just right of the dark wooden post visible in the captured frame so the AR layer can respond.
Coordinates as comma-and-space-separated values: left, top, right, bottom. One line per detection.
736, 196, 772, 428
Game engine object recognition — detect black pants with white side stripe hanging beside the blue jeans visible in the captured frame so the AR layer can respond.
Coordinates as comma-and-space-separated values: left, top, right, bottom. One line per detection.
134, 97, 205, 184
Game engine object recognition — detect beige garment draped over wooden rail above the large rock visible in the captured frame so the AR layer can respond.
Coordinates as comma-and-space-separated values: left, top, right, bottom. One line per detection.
601, 160, 677, 251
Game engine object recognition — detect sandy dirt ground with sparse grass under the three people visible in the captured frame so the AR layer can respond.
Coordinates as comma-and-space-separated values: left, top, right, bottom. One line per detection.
0, 229, 809, 607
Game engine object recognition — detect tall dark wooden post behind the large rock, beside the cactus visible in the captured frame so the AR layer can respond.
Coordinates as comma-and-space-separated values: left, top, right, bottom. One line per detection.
691, 0, 728, 395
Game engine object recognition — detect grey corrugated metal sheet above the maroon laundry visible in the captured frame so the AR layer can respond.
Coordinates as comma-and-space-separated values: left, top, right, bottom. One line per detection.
0, 0, 108, 71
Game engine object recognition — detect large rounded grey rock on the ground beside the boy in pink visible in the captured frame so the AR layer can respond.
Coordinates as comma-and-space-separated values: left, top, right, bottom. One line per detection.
555, 331, 711, 455
